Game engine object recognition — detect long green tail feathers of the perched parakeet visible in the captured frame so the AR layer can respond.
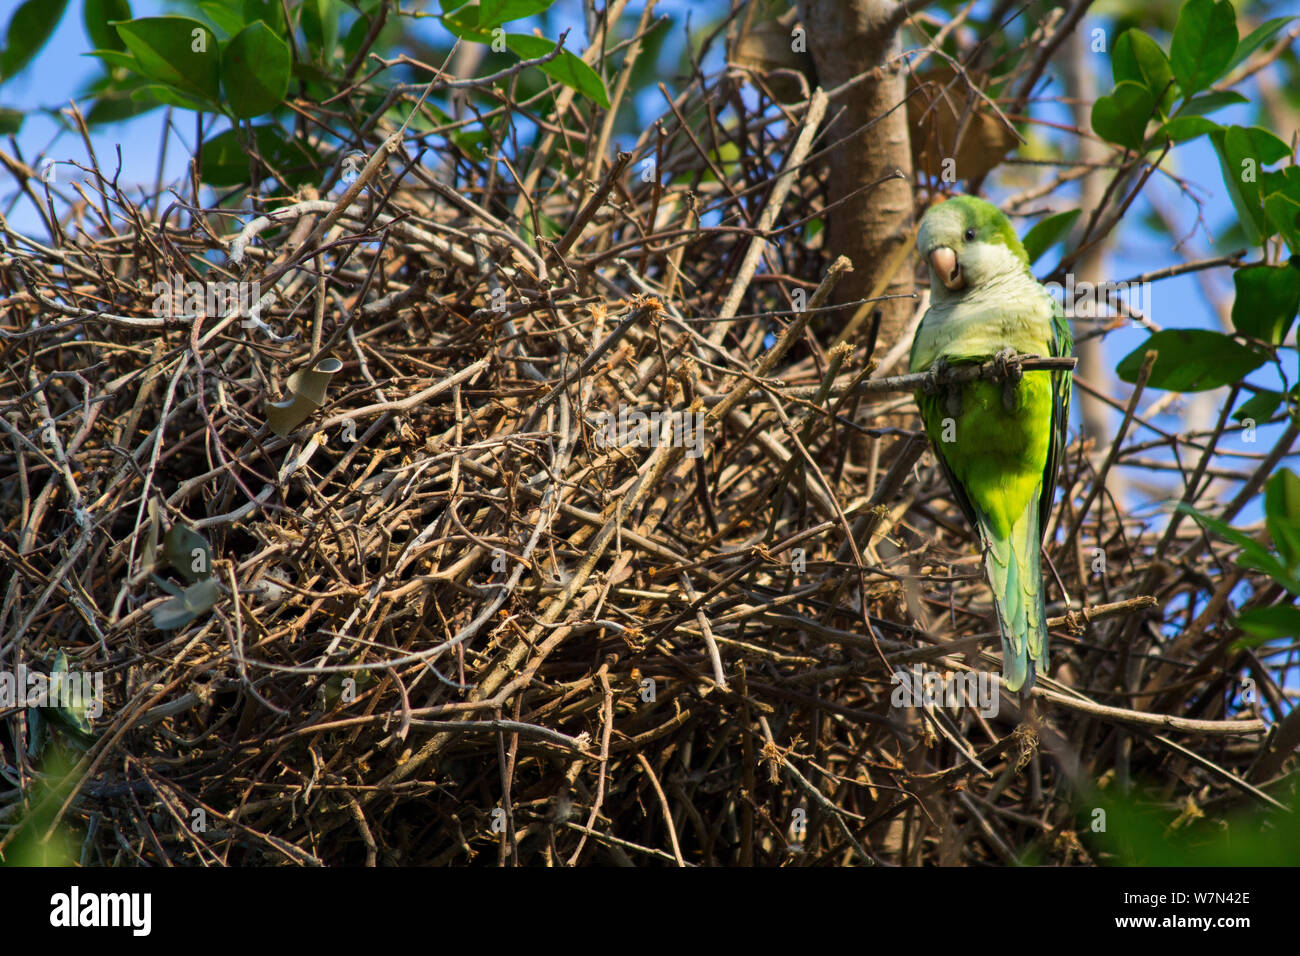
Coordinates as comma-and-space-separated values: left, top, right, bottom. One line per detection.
979, 501, 1048, 691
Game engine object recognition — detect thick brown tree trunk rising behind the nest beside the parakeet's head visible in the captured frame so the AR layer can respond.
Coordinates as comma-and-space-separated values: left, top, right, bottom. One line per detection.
801, 0, 915, 354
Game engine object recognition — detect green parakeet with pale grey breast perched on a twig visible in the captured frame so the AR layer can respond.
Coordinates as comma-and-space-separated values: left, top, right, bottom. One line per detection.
911, 196, 1073, 691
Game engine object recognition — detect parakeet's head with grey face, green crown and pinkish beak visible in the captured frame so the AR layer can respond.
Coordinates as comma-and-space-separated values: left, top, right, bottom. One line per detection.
917, 196, 1030, 298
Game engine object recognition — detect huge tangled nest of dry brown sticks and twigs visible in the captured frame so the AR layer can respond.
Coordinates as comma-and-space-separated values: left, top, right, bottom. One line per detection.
0, 67, 1281, 865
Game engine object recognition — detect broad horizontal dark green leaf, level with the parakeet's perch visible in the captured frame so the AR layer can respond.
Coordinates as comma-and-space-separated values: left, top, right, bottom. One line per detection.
1115, 329, 1268, 392
